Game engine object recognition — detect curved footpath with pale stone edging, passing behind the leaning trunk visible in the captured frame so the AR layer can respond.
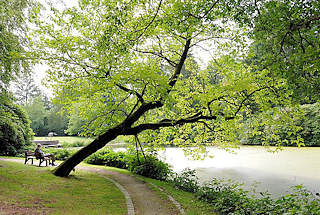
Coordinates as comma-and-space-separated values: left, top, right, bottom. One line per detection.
0, 158, 185, 215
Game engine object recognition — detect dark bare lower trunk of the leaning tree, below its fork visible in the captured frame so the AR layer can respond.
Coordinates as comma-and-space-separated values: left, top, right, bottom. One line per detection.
54, 127, 121, 177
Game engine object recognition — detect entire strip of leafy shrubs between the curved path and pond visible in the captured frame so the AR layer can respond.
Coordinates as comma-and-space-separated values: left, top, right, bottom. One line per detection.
86, 149, 320, 215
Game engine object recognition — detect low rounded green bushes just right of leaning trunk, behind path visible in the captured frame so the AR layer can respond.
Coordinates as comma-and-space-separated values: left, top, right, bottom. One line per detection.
86, 149, 171, 180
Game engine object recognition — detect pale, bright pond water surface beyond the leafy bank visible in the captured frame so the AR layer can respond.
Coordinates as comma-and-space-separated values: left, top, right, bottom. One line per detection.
160, 146, 320, 196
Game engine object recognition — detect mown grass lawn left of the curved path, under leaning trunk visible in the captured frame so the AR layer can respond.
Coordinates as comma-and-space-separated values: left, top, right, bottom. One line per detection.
0, 161, 127, 214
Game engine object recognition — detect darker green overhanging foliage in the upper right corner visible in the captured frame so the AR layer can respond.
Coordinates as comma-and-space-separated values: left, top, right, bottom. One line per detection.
252, 0, 320, 102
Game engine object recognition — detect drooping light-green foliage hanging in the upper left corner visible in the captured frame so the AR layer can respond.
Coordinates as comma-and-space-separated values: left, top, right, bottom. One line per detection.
0, 0, 32, 87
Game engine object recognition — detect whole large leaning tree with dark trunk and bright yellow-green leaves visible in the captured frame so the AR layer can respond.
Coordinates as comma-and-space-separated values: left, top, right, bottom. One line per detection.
34, 0, 308, 176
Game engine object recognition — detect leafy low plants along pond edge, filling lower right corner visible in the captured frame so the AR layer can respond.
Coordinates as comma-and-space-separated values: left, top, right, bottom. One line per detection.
173, 170, 320, 215
